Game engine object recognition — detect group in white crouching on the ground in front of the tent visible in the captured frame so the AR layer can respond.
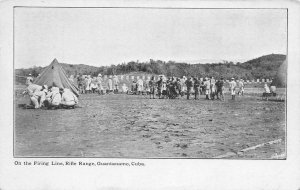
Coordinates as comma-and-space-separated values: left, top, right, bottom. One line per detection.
22, 77, 78, 109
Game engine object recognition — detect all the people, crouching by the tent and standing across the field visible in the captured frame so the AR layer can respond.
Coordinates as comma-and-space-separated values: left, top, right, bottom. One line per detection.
23, 74, 276, 109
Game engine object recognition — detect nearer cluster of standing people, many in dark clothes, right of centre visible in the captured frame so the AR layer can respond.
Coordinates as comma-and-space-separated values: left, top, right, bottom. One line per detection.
141, 75, 244, 100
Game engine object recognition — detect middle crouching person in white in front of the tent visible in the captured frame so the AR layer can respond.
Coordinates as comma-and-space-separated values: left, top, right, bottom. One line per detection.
44, 86, 61, 109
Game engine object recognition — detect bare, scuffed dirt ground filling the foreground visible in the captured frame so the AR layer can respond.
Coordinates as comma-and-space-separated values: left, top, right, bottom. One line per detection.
14, 89, 286, 159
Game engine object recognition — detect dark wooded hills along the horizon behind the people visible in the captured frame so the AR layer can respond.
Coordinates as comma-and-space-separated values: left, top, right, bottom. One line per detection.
15, 54, 286, 80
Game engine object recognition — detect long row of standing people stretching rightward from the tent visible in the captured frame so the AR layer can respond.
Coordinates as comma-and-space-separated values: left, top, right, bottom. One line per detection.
70, 74, 248, 100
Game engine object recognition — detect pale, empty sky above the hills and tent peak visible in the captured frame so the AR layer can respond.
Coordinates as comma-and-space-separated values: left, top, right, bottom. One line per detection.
14, 7, 287, 68
